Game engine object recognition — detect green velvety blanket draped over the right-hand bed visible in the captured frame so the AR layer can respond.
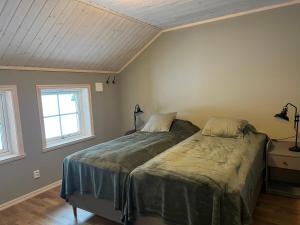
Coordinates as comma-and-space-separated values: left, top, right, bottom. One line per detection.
124, 132, 267, 225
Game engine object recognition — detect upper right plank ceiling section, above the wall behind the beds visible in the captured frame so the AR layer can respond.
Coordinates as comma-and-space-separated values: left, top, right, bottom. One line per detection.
86, 0, 289, 28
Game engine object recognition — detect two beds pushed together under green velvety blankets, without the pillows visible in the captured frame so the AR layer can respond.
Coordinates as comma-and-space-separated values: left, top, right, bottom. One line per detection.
61, 116, 268, 225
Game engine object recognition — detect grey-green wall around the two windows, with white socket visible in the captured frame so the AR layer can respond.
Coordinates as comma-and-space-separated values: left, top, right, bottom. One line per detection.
0, 70, 120, 204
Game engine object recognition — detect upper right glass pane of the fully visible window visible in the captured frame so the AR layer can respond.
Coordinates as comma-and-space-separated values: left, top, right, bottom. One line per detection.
59, 93, 78, 114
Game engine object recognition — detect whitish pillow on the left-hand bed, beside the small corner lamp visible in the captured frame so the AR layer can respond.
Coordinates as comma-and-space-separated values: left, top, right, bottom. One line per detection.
142, 112, 177, 132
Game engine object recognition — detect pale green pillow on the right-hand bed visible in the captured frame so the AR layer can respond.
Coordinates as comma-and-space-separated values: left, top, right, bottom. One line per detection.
202, 117, 248, 138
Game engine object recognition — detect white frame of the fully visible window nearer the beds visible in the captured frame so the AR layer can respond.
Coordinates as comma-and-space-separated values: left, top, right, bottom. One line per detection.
36, 84, 95, 152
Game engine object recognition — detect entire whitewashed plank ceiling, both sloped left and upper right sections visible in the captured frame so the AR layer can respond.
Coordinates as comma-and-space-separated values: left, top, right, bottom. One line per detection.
0, 0, 296, 73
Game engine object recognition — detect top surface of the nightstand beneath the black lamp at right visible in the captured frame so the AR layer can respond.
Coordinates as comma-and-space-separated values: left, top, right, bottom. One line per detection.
269, 141, 300, 158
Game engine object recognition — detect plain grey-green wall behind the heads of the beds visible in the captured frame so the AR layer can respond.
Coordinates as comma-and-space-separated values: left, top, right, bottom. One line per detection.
120, 4, 300, 138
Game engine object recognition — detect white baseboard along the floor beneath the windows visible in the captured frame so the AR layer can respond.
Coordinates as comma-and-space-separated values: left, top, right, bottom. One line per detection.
0, 180, 61, 211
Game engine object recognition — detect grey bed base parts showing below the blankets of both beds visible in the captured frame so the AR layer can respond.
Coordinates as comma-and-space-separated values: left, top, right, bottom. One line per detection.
69, 172, 265, 225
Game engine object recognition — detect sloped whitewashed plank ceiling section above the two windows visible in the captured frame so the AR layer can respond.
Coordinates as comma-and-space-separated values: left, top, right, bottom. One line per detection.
0, 0, 159, 71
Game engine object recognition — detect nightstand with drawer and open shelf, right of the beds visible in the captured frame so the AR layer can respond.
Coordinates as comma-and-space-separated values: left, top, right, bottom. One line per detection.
266, 141, 300, 198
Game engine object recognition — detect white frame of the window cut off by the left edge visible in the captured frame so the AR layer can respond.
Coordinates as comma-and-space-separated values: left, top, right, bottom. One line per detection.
0, 85, 25, 164
